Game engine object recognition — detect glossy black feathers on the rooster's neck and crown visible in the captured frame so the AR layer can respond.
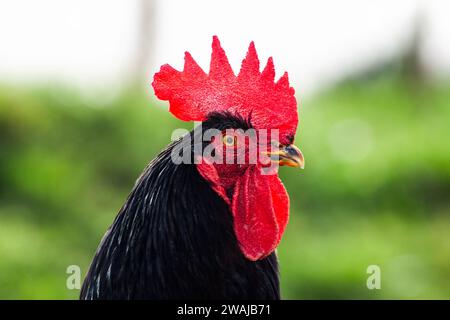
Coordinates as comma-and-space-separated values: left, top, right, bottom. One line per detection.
80, 114, 280, 299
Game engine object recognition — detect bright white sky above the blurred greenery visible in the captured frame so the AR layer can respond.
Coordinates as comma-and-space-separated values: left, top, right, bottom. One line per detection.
0, 0, 450, 94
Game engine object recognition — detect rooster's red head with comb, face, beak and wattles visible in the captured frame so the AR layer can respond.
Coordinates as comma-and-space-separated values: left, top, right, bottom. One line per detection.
152, 36, 304, 261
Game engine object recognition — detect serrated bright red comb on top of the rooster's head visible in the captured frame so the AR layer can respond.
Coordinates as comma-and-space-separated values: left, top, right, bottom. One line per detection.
152, 36, 298, 143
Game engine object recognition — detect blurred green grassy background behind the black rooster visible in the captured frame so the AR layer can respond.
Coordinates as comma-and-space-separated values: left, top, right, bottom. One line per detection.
0, 60, 450, 299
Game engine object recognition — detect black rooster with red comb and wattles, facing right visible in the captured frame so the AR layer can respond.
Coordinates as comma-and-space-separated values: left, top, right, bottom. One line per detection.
80, 36, 304, 300
